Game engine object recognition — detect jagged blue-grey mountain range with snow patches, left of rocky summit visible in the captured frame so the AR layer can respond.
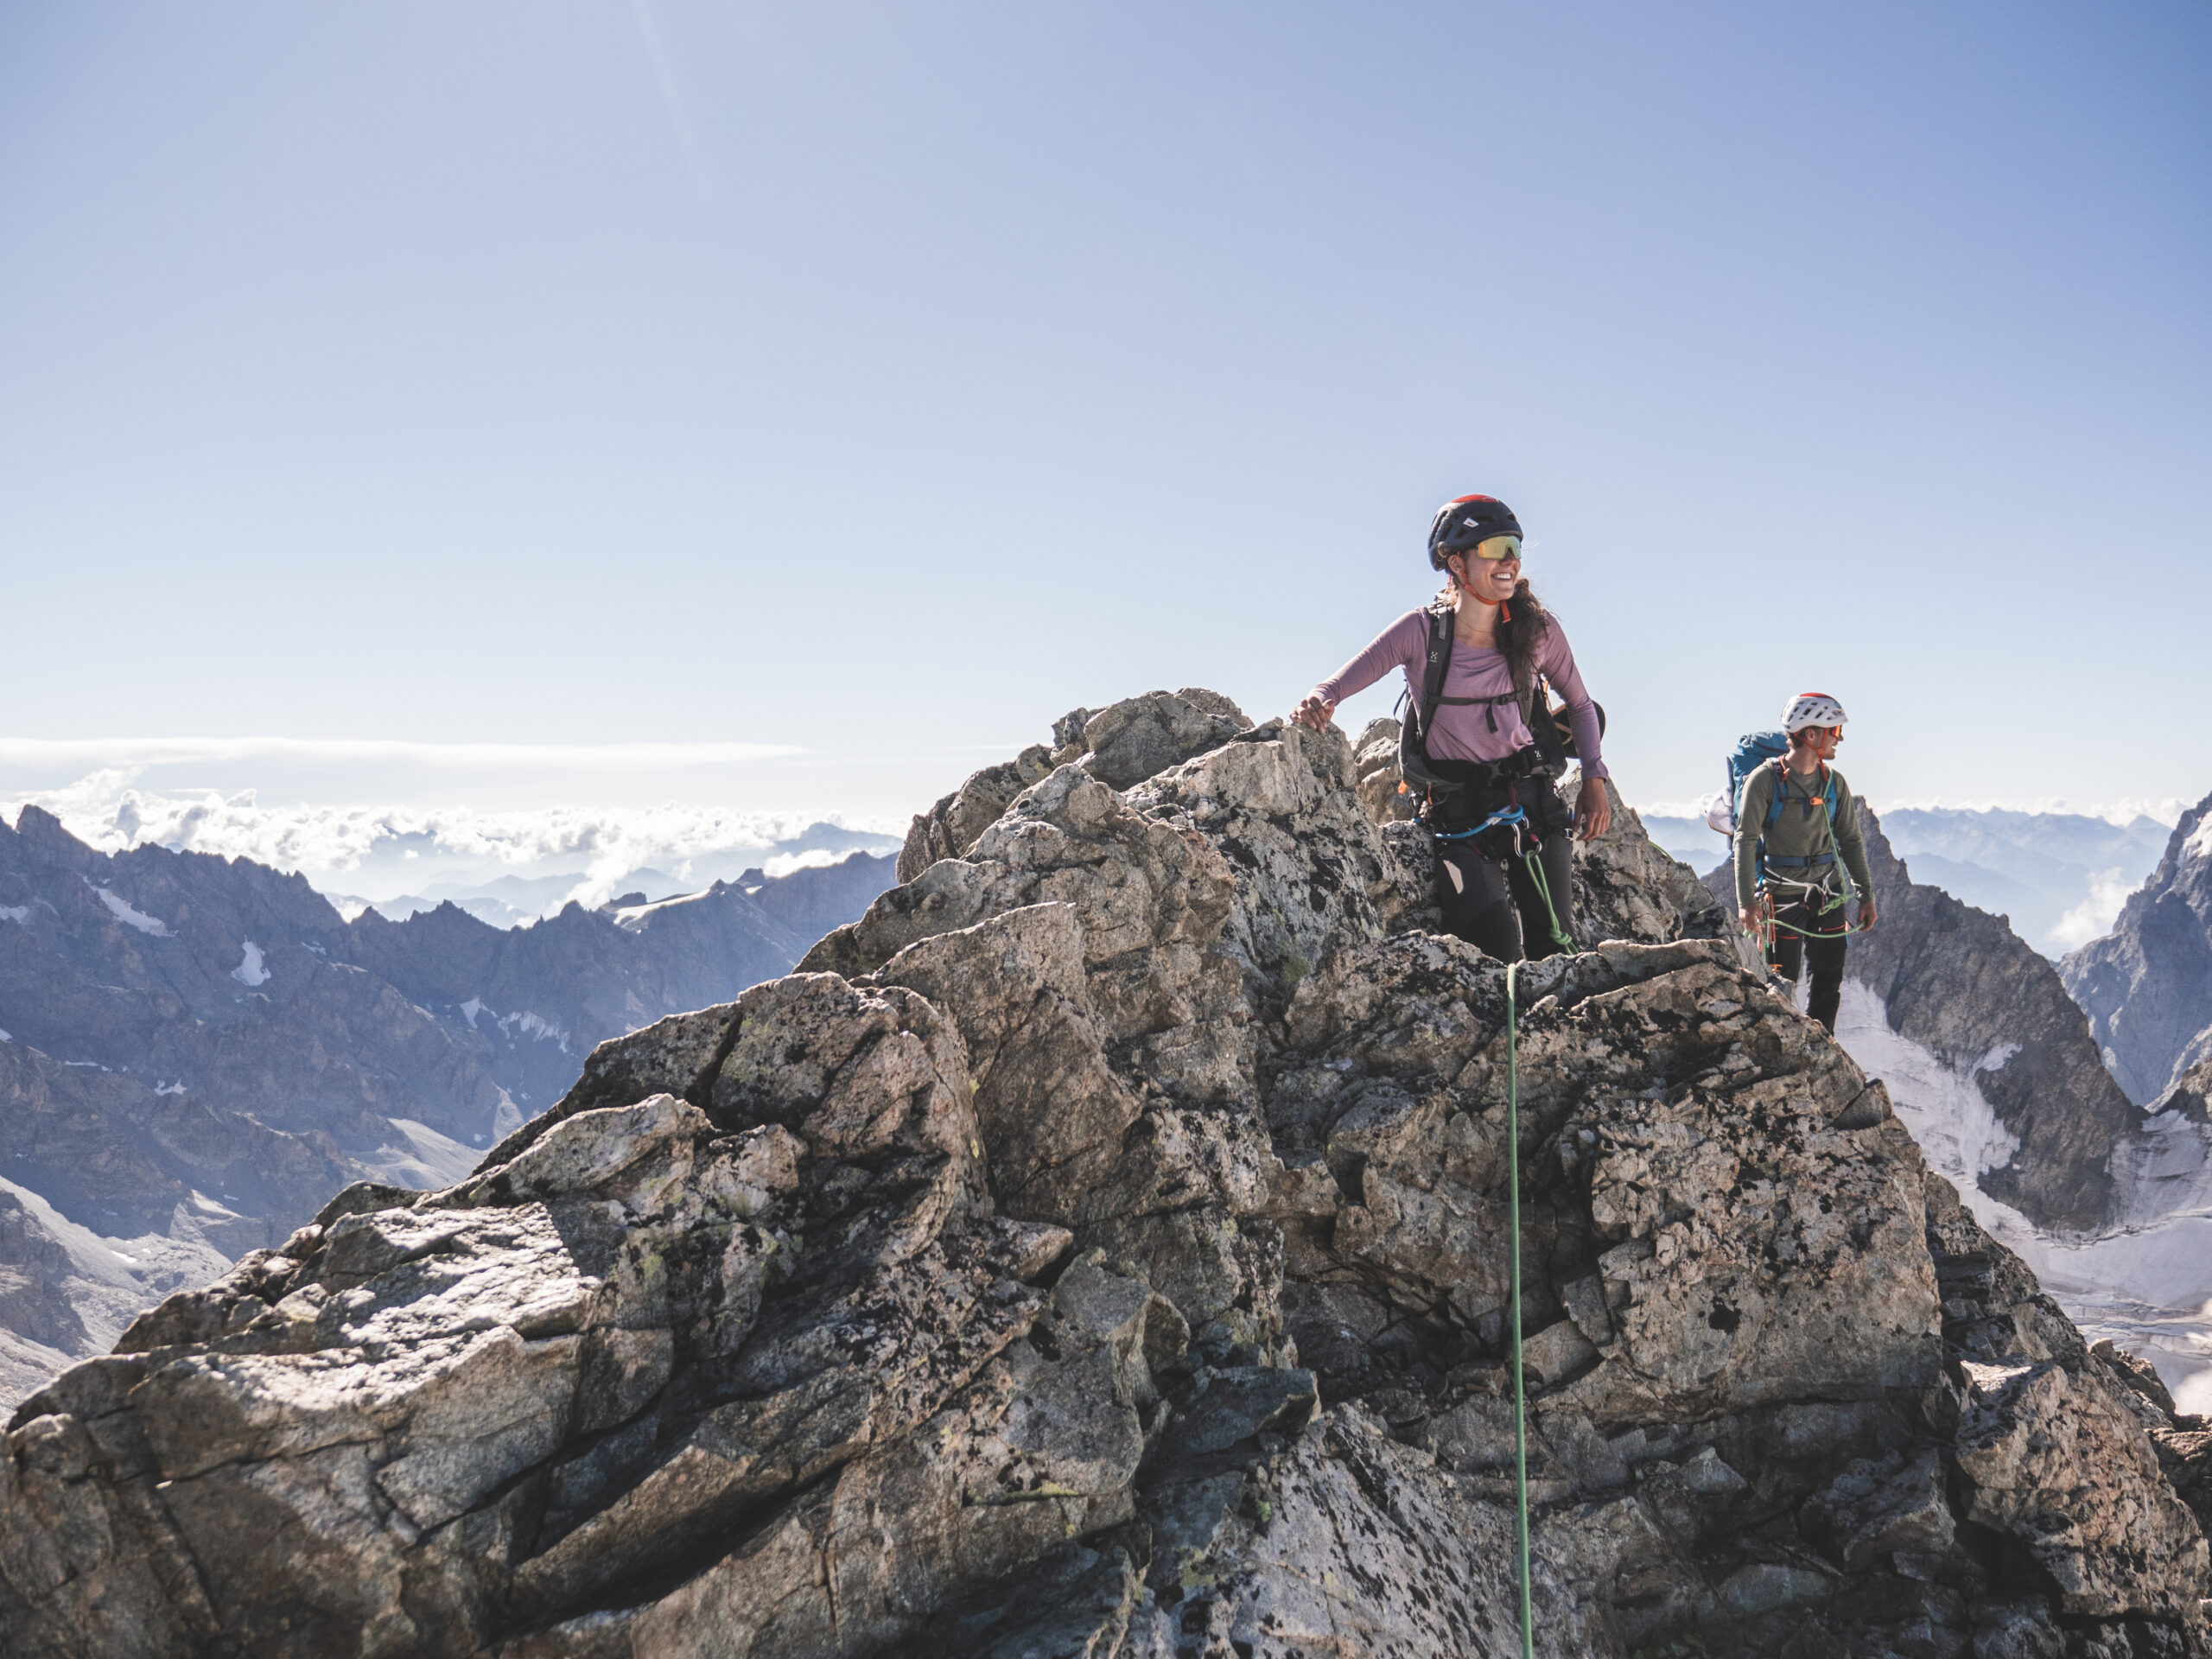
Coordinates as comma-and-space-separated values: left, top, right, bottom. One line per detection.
0, 807, 893, 1395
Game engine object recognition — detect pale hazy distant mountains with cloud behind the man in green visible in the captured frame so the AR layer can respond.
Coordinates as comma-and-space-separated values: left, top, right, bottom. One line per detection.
1643, 807, 2168, 957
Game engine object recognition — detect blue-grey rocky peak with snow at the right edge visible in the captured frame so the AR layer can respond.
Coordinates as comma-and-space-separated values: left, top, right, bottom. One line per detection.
2062, 797, 2212, 1103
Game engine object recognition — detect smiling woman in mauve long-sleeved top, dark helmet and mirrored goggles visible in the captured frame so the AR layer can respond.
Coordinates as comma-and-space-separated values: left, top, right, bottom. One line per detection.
1292, 495, 1612, 963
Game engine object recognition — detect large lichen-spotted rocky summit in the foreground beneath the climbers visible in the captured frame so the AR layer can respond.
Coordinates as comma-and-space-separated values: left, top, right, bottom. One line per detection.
0, 692, 2208, 1659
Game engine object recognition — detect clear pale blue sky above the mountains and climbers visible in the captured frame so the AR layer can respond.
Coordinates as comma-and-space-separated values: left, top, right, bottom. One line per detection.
0, 0, 2212, 831
